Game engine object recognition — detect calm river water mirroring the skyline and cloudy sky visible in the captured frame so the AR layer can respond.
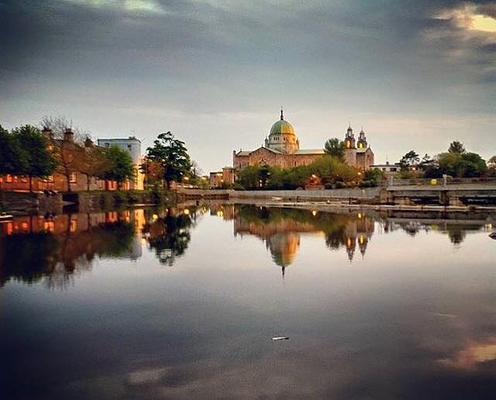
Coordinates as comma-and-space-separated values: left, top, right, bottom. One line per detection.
0, 206, 496, 400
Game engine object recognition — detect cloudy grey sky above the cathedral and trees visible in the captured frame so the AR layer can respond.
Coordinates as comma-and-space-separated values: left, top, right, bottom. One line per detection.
0, 0, 496, 173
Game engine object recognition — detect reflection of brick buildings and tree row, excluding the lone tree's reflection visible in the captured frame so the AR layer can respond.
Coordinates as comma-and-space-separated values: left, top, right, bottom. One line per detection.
0, 210, 143, 288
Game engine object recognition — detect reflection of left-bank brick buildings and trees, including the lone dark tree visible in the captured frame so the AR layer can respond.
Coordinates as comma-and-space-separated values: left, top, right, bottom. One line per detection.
0, 208, 202, 288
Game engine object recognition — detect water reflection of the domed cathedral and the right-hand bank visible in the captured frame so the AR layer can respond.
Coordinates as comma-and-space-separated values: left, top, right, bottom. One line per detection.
210, 204, 491, 275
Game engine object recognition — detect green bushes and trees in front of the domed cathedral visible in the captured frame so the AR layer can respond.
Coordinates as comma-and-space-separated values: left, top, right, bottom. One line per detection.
235, 155, 358, 190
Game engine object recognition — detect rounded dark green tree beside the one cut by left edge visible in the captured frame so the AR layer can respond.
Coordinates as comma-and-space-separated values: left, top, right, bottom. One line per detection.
12, 125, 57, 191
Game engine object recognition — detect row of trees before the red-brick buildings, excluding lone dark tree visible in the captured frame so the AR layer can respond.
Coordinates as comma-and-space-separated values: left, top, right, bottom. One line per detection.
0, 117, 135, 191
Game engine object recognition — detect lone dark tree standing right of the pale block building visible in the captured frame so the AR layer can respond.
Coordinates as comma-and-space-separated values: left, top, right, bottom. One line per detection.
147, 132, 191, 189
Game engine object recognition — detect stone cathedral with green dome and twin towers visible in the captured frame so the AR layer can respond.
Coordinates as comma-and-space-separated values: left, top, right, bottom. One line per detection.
233, 109, 374, 171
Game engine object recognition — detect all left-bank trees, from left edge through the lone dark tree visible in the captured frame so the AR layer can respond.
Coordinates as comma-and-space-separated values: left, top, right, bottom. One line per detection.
0, 117, 201, 191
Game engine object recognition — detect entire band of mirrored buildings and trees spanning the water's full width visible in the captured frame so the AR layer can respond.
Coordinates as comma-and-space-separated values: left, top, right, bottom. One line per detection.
0, 204, 492, 287
